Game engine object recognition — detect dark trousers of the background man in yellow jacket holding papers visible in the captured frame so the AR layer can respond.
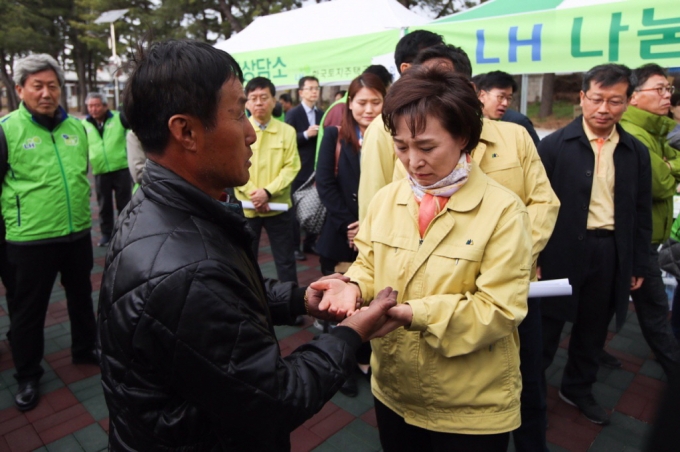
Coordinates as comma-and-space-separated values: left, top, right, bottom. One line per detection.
248, 210, 297, 284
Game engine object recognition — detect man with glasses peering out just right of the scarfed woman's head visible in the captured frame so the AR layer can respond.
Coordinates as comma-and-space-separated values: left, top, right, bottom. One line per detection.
472, 71, 541, 147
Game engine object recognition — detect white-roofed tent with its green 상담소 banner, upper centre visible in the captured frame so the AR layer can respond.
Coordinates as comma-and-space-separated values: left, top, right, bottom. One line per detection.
215, 0, 429, 89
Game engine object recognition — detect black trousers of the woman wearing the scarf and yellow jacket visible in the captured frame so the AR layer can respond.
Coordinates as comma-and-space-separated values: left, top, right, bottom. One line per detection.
374, 399, 510, 452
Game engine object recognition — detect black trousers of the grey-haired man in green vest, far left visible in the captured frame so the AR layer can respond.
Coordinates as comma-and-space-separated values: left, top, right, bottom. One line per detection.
7, 234, 97, 383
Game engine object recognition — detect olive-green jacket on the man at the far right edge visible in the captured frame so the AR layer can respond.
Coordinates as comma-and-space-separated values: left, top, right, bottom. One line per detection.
621, 105, 680, 243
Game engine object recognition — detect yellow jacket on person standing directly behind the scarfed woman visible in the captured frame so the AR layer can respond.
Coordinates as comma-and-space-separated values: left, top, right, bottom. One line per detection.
359, 116, 560, 263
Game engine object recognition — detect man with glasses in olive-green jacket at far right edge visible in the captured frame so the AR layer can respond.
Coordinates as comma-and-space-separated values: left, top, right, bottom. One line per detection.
621, 64, 680, 375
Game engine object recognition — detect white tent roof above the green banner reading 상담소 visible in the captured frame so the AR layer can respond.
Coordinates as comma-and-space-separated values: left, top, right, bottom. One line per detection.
215, 0, 429, 54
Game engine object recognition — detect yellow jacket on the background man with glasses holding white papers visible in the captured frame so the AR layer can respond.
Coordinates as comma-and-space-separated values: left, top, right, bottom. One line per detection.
235, 117, 300, 218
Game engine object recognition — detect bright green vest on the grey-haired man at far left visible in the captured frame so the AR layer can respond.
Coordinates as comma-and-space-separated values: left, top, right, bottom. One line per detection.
0, 102, 92, 242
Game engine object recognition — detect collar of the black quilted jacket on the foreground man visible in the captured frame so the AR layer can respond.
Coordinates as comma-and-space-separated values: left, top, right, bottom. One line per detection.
140, 160, 252, 244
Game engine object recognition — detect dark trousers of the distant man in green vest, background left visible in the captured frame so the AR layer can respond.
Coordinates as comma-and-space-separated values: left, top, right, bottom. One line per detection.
94, 168, 132, 237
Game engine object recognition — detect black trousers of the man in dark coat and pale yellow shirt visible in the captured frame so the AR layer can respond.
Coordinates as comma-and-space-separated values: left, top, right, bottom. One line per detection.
542, 231, 617, 397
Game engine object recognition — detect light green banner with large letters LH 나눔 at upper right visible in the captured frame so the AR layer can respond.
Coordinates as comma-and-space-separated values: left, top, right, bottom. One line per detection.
417, 0, 680, 74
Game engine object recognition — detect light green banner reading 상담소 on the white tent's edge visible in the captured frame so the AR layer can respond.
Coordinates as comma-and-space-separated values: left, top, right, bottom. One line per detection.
233, 30, 400, 88
